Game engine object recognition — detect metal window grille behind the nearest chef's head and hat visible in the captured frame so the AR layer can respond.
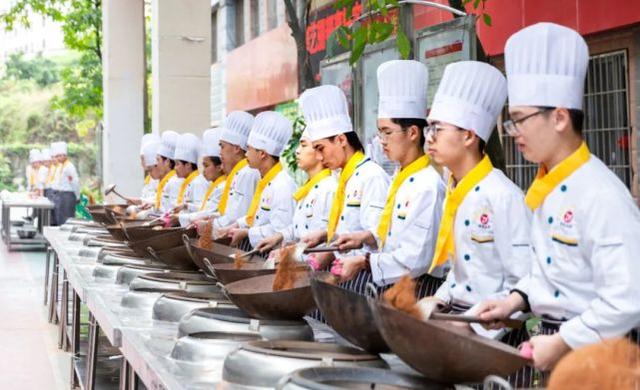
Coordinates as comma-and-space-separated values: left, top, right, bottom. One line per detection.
503, 50, 632, 189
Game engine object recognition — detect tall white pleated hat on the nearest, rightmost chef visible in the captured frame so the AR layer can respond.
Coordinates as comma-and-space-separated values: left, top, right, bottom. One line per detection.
504, 23, 589, 110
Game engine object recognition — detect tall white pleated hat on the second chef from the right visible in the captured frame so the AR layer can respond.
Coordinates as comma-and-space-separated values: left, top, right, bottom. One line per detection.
428, 61, 507, 141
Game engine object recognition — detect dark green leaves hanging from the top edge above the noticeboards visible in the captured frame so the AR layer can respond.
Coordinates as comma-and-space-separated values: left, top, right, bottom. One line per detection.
330, 0, 491, 66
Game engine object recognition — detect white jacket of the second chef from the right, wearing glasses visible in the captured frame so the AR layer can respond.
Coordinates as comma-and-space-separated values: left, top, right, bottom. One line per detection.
435, 168, 533, 306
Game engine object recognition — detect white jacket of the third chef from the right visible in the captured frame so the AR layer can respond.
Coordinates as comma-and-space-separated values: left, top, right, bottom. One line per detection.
370, 165, 445, 286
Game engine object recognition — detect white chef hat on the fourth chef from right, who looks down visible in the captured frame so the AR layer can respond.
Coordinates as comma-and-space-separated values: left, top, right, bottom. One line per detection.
298, 85, 353, 141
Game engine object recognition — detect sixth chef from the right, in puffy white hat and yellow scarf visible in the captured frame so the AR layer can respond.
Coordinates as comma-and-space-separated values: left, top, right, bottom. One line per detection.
229, 111, 296, 248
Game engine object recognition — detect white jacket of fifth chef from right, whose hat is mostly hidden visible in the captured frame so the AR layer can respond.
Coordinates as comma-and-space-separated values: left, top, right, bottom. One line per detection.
280, 175, 338, 243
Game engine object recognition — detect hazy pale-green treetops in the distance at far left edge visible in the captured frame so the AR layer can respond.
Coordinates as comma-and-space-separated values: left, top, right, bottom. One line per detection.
5, 53, 59, 87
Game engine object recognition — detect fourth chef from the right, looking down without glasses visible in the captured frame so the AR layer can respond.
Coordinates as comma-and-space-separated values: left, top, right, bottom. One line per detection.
300, 85, 389, 293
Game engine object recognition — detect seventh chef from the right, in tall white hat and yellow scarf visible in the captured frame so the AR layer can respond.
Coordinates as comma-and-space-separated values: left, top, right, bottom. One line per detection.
213, 111, 260, 235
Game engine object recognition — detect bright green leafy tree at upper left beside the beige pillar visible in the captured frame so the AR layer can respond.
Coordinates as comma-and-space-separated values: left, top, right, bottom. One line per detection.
0, 0, 102, 118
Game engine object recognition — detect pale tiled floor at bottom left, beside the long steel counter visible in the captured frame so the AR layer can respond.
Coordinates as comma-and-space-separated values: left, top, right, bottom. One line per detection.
0, 243, 71, 390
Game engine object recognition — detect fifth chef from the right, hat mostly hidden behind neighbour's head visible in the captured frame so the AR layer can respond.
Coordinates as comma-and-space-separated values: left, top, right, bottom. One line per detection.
252, 125, 338, 252
